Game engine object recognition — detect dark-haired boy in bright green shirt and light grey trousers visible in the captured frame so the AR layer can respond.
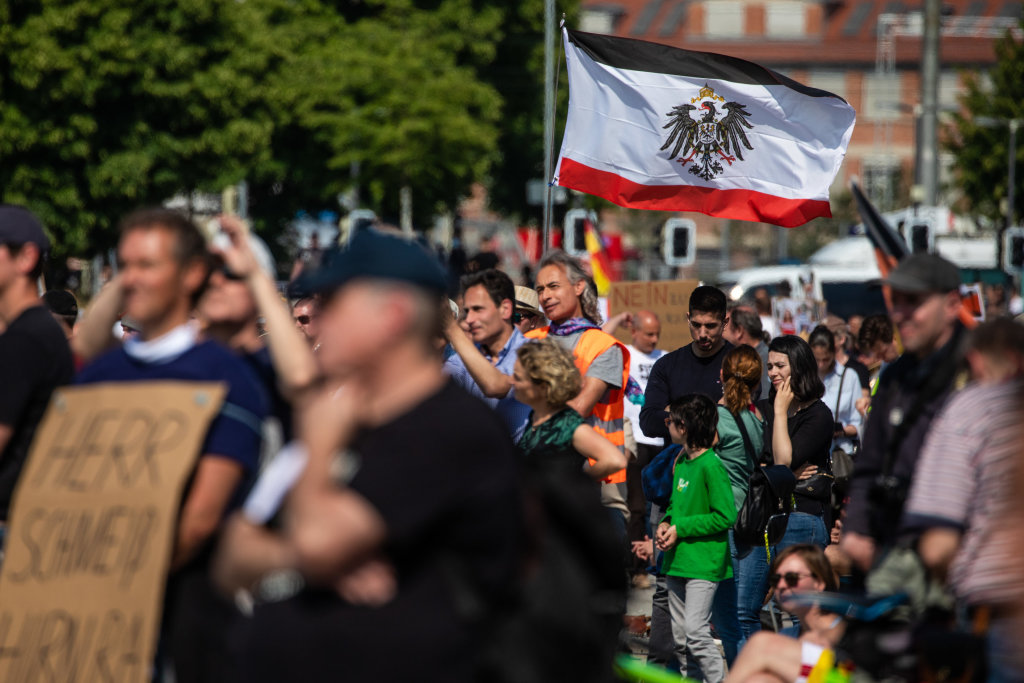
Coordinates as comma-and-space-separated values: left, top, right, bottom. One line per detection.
655, 394, 736, 683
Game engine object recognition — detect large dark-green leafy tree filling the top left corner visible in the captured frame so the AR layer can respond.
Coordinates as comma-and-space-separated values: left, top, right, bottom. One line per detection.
0, 0, 273, 254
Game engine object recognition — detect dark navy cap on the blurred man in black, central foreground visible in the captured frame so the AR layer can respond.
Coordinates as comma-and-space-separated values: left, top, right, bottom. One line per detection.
289, 229, 447, 297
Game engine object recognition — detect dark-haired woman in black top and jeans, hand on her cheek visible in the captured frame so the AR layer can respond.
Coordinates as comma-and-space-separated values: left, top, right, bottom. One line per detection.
736, 335, 835, 638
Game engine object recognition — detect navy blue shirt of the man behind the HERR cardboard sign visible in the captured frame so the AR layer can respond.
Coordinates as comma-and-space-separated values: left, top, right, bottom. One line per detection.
75, 341, 268, 509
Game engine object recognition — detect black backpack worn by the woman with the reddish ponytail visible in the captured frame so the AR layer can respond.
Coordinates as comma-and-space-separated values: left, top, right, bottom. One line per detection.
735, 465, 797, 547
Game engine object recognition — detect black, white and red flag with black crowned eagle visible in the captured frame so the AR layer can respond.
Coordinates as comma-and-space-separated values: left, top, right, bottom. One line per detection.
555, 29, 856, 227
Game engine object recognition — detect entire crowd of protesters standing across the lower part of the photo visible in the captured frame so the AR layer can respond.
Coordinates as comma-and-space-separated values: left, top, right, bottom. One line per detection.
0, 206, 1024, 683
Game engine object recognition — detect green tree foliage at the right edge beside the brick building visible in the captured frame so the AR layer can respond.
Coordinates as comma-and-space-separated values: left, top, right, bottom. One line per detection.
945, 22, 1024, 224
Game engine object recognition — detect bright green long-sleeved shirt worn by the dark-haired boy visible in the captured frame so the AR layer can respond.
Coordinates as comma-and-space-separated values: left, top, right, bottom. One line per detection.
662, 449, 736, 582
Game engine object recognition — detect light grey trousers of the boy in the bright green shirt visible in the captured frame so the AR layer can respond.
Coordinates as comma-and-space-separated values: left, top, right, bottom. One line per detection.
667, 577, 725, 683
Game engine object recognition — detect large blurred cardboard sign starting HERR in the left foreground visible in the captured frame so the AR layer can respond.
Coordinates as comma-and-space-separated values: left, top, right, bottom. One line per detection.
0, 382, 224, 683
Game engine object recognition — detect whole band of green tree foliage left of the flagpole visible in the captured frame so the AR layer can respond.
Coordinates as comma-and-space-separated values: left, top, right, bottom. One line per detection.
0, 0, 540, 254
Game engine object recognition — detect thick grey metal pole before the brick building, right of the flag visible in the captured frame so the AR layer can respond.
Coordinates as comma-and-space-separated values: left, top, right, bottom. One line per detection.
921, 0, 942, 206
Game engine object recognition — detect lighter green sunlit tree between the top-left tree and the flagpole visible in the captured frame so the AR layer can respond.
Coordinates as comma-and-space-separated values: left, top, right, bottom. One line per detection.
246, 0, 502, 231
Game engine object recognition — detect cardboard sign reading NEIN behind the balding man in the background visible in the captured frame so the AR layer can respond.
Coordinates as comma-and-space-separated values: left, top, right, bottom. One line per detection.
608, 280, 700, 351
